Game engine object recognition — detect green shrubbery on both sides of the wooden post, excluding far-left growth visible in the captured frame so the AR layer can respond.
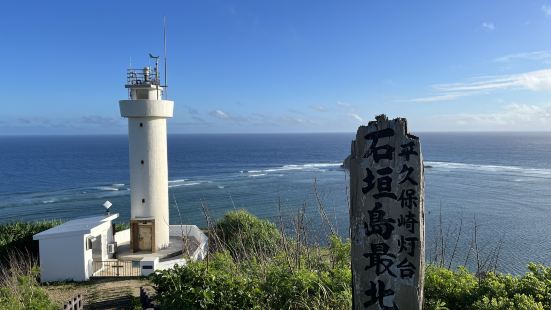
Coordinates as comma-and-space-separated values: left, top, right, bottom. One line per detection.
152, 211, 551, 310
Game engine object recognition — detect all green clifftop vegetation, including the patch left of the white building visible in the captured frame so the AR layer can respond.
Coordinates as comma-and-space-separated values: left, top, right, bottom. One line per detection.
0, 210, 551, 310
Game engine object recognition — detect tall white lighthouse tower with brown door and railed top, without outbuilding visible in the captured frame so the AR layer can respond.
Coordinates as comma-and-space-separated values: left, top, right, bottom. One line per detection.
119, 56, 174, 253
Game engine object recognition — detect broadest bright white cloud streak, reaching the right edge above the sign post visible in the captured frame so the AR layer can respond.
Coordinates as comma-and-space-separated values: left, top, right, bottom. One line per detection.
406, 69, 551, 102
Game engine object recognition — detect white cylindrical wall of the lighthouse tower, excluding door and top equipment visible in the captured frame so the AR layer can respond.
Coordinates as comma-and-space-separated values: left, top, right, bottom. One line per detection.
119, 93, 174, 249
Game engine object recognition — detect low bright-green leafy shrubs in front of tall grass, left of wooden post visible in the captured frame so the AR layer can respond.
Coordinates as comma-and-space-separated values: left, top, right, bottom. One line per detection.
152, 252, 352, 309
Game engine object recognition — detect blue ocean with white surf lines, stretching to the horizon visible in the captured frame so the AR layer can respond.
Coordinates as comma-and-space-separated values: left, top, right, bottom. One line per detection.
0, 133, 551, 274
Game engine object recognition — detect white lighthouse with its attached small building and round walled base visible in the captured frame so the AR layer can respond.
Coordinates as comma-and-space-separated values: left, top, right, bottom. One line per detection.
33, 47, 208, 282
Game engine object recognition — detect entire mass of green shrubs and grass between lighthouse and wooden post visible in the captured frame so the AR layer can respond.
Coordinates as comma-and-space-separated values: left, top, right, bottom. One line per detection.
152, 210, 352, 309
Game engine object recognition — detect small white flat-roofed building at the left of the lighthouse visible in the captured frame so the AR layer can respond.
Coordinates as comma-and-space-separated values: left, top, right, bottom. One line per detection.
33, 214, 119, 282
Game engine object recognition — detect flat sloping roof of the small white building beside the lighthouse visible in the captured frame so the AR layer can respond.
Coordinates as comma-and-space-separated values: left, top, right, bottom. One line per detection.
33, 213, 119, 240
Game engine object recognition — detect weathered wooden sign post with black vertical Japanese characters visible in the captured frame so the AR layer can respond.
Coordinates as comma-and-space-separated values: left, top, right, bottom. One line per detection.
349, 115, 425, 310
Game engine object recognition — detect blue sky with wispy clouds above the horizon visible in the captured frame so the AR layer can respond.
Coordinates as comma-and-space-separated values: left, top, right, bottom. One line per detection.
0, 0, 551, 134
